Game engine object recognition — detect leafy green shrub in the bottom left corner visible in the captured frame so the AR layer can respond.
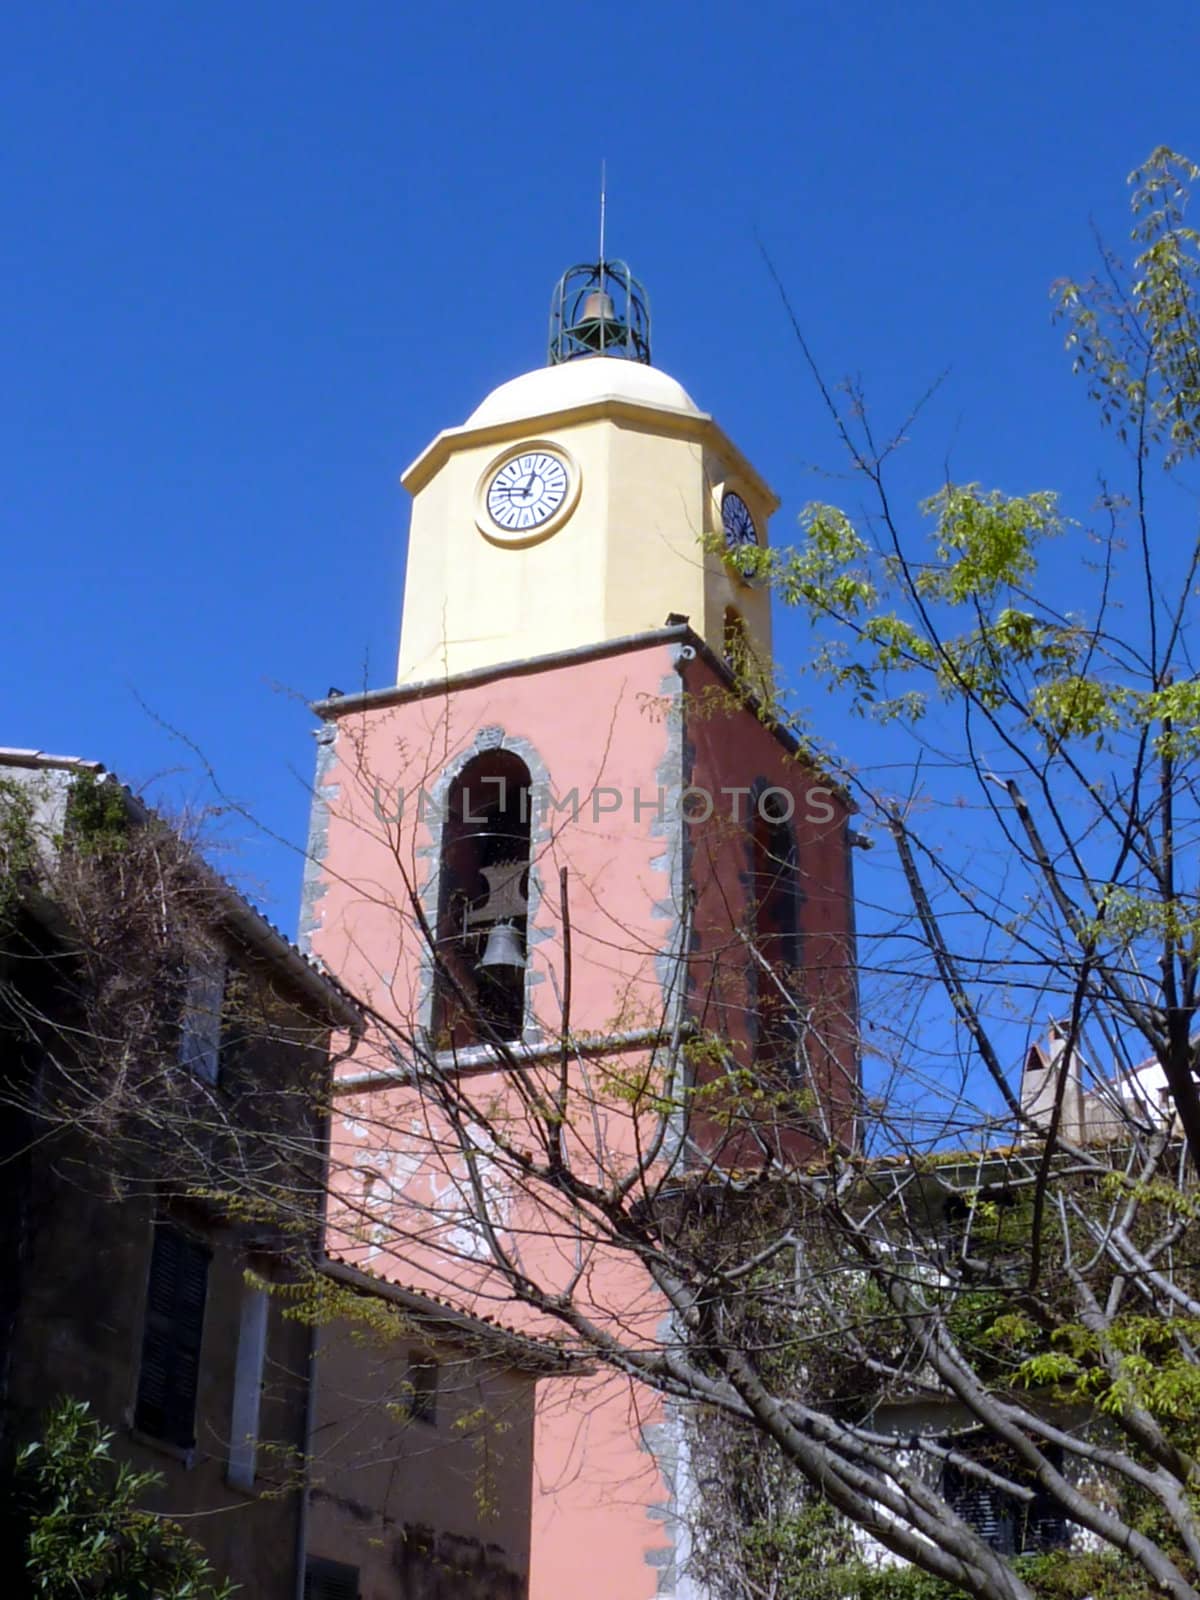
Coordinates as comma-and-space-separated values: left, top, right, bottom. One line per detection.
19, 1400, 235, 1600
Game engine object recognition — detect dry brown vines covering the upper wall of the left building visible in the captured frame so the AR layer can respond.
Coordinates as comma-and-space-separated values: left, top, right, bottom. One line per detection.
0, 773, 328, 1238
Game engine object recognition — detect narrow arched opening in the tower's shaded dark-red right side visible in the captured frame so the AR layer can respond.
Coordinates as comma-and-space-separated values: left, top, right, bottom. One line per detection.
750, 789, 802, 1082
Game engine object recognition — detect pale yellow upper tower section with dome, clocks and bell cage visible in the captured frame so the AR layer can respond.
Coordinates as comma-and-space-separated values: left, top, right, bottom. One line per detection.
397, 261, 779, 683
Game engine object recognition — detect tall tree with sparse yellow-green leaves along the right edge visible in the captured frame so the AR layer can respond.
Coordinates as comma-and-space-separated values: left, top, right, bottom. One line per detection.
659, 140, 1200, 1594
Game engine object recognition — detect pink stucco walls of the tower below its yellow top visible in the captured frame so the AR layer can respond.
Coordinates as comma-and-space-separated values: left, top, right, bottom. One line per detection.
310, 642, 854, 1600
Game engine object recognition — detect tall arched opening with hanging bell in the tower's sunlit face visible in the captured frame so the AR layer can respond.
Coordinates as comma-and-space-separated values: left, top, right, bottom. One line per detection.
432, 750, 531, 1050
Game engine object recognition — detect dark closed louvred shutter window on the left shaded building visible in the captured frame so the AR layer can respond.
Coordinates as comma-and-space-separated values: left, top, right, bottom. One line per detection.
133, 1222, 210, 1450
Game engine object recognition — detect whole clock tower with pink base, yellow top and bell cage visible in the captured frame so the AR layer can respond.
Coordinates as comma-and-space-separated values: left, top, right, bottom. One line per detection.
304, 262, 858, 1600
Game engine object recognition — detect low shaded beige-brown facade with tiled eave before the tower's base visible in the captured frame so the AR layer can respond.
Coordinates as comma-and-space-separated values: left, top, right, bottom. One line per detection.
307, 1261, 562, 1600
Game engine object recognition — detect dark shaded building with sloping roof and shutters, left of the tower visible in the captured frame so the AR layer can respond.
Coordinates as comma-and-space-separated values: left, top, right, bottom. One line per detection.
0, 750, 358, 1600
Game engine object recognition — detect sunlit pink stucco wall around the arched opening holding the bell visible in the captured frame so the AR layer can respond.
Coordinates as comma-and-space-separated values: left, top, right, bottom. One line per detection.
312, 648, 681, 1029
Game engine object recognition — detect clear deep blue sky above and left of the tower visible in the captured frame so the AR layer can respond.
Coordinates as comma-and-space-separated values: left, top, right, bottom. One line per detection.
0, 0, 1200, 926
